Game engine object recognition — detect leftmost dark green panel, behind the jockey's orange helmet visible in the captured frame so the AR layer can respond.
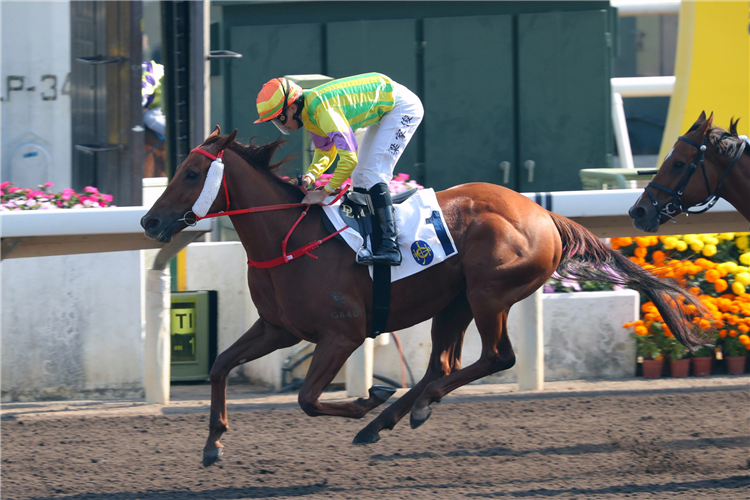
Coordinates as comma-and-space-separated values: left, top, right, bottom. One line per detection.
229, 24, 322, 175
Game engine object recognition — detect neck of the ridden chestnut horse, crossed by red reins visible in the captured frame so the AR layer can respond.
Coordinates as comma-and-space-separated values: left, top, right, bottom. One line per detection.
224, 153, 312, 261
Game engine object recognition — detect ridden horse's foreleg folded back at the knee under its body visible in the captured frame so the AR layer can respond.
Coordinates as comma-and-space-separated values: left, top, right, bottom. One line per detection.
298, 335, 396, 418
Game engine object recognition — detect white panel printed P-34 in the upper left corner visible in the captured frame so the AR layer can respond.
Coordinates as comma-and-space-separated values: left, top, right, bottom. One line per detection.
0, 0, 72, 191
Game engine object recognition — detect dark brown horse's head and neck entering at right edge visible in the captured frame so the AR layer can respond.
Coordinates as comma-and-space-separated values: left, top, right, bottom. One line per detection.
628, 112, 750, 233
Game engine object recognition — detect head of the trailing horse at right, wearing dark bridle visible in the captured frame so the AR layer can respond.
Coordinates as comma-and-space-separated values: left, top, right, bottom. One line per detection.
628, 112, 720, 233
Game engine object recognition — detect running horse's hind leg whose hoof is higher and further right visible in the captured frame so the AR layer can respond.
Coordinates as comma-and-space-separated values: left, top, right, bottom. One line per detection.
410, 300, 516, 429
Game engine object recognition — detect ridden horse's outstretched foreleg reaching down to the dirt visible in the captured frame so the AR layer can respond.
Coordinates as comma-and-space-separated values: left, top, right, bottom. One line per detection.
203, 320, 299, 466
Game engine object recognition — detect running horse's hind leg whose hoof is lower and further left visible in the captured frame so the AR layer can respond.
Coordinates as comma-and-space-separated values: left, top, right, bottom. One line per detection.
353, 293, 472, 444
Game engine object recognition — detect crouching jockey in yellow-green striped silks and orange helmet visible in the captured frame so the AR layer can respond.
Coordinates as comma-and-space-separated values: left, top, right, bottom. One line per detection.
255, 73, 424, 266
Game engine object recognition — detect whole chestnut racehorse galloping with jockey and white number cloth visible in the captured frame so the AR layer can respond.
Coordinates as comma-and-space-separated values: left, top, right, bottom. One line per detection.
141, 127, 703, 466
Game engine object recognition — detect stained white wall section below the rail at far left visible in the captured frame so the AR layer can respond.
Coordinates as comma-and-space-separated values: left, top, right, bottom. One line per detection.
0, 251, 145, 402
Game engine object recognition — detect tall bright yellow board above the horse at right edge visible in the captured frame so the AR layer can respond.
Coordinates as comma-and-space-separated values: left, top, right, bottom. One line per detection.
657, 0, 750, 162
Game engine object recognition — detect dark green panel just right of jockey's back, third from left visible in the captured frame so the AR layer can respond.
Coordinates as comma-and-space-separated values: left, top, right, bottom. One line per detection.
423, 16, 515, 189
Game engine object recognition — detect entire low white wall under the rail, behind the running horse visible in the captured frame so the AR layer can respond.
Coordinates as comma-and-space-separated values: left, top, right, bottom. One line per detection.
0, 236, 639, 401
